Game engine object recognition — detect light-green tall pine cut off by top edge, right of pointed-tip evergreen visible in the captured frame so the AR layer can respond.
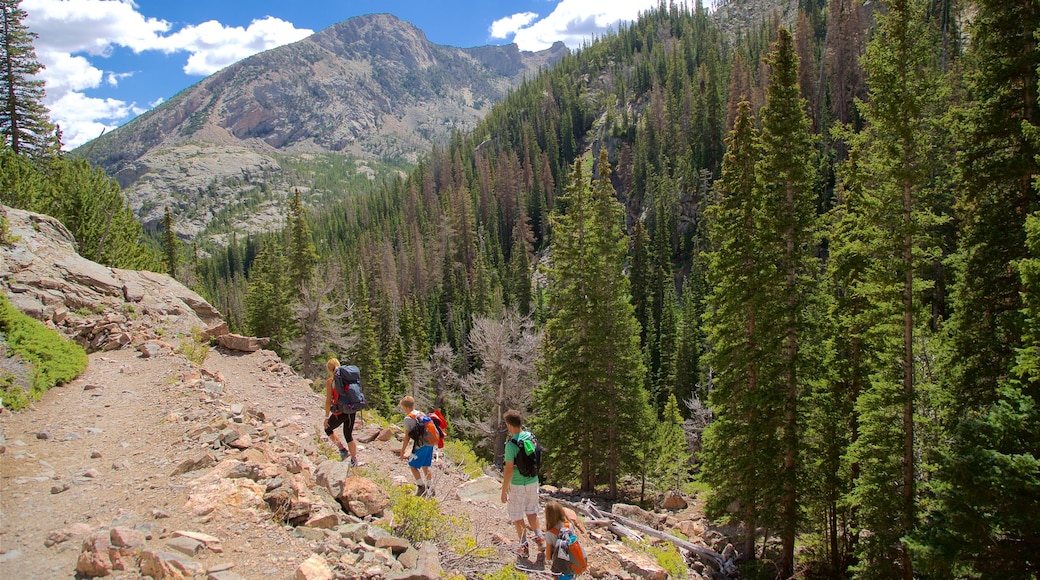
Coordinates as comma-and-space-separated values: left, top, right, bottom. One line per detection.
850, 0, 942, 579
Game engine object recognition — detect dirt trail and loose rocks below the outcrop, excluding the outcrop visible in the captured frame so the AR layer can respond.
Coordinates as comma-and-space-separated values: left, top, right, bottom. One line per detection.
0, 341, 736, 580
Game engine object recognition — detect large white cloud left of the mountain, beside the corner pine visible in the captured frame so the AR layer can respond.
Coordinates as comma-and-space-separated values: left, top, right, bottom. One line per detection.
22, 0, 312, 149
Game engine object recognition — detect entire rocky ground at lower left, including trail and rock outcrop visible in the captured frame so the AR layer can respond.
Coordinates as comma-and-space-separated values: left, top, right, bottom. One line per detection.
0, 206, 734, 580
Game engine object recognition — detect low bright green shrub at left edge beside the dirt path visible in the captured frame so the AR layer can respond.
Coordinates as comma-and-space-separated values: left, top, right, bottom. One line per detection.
0, 294, 86, 411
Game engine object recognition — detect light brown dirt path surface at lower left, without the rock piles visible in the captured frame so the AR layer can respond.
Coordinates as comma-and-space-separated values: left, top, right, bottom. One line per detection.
0, 349, 513, 580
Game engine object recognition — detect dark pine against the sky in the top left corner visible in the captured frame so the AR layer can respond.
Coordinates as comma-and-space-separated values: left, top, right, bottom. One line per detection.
0, 0, 55, 157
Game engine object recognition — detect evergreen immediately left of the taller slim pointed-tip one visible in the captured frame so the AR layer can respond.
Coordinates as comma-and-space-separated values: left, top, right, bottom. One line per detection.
701, 101, 781, 559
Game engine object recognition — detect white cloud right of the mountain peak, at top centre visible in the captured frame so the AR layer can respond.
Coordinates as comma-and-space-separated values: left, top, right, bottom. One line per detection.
493, 0, 684, 51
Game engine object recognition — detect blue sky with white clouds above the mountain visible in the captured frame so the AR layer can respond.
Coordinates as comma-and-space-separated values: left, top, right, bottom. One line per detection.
22, 0, 694, 149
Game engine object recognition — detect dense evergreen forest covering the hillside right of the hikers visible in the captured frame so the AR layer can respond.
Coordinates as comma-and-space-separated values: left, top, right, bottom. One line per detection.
0, 0, 1040, 579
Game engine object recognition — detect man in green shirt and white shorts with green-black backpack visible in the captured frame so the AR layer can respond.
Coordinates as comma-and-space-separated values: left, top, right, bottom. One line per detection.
502, 410, 545, 559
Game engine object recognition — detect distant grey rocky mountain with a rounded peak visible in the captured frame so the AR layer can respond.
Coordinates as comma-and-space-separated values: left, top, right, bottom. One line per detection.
78, 15, 567, 235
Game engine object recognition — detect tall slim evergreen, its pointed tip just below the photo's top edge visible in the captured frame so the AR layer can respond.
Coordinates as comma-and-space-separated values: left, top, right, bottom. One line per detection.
755, 28, 825, 578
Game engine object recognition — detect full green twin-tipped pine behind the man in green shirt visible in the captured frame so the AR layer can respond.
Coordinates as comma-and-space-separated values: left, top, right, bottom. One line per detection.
536, 148, 649, 497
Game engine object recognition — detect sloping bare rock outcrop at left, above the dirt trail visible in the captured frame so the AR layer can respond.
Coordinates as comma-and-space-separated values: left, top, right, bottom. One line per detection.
0, 207, 220, 351
